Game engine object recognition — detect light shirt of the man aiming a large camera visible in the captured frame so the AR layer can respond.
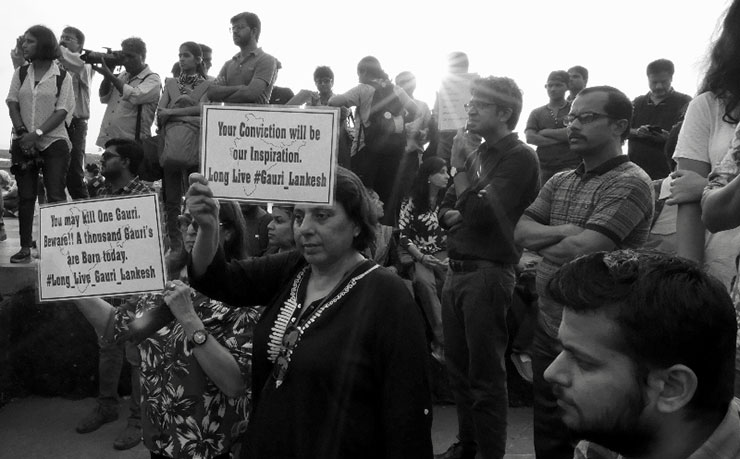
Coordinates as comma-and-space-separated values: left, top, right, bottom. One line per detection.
95, 66, 162, 148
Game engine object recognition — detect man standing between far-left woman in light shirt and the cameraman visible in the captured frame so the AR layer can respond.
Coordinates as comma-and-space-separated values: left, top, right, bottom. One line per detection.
59, 26, 93, 199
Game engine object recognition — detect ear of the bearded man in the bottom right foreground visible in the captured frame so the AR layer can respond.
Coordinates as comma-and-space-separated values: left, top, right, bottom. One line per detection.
647, 364, 699, 413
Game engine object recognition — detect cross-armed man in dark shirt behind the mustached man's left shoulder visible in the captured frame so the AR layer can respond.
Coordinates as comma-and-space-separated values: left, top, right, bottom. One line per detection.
524, 70, 581, 183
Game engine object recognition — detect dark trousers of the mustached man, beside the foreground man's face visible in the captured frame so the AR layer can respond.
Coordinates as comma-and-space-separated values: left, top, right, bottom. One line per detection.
532, 318, 575, 459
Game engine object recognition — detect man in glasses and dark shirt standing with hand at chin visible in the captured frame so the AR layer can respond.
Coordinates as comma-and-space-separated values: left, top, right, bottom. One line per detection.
435, 77, 540, 459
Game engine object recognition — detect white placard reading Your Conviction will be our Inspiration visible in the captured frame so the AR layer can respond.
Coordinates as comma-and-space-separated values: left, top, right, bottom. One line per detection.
200, 104, 340, 204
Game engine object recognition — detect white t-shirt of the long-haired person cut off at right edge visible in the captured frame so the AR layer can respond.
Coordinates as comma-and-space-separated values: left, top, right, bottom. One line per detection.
673, 92, 740, 289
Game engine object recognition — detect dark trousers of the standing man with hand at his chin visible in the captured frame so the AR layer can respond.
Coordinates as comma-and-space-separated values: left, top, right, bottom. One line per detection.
442, 262, 515, 459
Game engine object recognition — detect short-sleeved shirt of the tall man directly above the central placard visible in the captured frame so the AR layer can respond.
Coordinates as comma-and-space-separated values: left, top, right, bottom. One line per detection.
216, 48, 277, 104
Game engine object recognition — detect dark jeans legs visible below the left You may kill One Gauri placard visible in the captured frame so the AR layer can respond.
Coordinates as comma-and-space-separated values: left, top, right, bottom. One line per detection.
98, 340, 141, 427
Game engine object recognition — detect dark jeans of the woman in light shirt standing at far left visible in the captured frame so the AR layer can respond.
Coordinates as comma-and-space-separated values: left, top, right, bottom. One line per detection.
11, 140, 69, 247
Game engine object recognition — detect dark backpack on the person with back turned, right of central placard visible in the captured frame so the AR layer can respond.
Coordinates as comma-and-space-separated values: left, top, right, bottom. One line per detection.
362, 81, 406, 154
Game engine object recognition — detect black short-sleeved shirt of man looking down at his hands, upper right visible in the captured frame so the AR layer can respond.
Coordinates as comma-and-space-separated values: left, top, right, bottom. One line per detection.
628, 91, 691, 180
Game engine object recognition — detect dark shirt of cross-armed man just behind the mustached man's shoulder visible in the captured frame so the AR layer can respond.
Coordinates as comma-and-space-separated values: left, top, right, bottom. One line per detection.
527, 102, 581, 182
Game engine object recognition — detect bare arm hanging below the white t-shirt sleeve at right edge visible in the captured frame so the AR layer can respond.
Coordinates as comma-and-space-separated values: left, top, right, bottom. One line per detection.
671, 158, 710, 263
